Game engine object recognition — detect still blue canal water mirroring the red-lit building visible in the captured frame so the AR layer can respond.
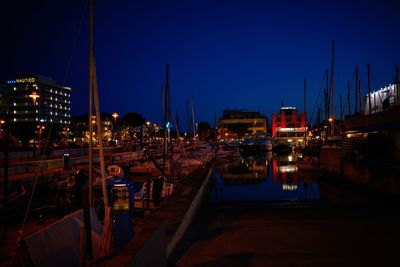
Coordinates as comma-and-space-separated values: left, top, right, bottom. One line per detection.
211, 153, 320, 202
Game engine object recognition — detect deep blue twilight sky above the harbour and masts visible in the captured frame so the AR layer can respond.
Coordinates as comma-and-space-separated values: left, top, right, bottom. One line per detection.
0, 0, 400, 130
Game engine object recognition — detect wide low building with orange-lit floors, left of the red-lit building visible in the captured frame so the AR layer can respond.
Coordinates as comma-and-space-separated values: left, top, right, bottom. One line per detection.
218, 109, 268, 139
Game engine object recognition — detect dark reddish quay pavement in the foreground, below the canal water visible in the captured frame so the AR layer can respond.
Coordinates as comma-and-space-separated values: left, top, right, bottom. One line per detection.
169, 205, 400, 267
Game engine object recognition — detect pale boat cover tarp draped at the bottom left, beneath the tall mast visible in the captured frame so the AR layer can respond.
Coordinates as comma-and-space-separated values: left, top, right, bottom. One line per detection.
22, 208, 103, 267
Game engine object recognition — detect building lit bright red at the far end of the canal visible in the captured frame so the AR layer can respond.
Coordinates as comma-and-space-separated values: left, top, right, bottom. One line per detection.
272, 107, 307, 145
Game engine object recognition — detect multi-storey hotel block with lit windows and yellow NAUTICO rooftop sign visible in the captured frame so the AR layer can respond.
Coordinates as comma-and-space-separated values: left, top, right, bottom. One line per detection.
1, 76, 71, 127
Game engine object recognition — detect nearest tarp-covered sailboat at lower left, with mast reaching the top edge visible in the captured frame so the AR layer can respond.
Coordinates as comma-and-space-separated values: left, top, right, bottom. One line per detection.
17, 0, 111, 267
